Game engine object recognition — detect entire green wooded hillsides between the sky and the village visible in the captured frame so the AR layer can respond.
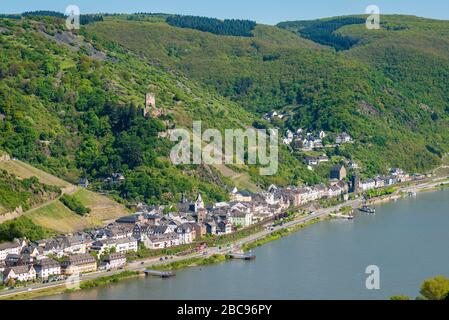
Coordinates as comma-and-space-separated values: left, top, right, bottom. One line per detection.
0, 14, 449, 203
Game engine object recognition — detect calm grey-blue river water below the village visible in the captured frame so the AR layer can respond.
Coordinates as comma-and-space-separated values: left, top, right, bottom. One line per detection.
46, 190, 449, 300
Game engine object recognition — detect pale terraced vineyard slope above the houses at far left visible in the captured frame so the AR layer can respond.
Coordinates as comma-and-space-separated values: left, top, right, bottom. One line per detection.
0, 154, 129, 233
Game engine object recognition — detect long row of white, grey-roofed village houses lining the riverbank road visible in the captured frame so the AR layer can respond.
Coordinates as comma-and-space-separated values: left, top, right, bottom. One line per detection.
0, 161, 414, 287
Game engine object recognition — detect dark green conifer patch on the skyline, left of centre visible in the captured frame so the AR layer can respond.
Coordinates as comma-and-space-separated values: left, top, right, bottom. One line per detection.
166, 15, 256, 37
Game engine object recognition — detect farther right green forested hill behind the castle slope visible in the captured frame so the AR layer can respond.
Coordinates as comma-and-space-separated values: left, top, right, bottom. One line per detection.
86, 16, 449, 175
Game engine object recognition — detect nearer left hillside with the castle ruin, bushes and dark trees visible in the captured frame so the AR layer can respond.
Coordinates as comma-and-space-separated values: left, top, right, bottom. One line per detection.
0, 13, 319, 203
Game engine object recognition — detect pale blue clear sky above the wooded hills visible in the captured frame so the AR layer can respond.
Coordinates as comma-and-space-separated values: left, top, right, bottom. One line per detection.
0, 0, 449, 24
